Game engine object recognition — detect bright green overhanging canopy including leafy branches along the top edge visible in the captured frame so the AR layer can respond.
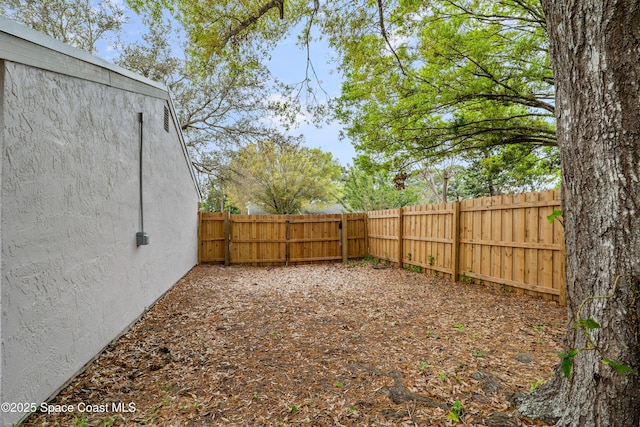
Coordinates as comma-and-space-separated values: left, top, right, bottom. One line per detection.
129, 0, 555, 170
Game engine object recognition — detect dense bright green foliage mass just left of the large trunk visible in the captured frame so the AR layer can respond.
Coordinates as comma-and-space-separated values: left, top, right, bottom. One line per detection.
332, 0, 556, 169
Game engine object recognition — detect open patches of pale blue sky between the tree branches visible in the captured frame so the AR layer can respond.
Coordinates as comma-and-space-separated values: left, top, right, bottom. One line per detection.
98, 5, 355, 166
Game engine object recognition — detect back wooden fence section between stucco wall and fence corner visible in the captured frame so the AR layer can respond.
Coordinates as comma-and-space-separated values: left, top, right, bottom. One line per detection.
198, 212, 367, 264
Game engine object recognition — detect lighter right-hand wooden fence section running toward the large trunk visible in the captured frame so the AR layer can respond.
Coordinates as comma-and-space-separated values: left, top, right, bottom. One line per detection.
368, 190, 566, 305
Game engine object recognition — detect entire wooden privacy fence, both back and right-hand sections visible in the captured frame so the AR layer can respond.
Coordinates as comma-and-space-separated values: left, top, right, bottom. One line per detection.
198, 190, 566, 305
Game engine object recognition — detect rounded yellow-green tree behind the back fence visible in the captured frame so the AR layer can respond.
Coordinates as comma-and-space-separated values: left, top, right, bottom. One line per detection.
228, 138, 341, 214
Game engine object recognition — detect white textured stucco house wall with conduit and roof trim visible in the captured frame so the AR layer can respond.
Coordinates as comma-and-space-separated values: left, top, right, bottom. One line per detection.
0, 18, 200, 426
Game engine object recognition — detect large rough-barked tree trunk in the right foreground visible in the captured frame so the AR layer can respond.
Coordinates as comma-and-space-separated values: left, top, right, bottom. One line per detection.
520, 0, 640, 427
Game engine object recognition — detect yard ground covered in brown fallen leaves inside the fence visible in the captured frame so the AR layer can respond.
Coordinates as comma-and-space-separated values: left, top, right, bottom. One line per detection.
25, 263, 566, 426
